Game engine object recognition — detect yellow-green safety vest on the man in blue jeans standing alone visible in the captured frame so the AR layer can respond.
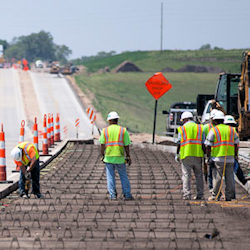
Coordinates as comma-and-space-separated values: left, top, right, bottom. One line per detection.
103, 125, 126, 156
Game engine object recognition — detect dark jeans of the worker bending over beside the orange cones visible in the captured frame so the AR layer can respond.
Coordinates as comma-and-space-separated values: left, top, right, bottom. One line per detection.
19, 159, 40, 194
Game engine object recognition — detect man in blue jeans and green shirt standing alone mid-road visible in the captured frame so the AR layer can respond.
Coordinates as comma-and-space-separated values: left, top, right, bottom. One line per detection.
99, 111, 133, 200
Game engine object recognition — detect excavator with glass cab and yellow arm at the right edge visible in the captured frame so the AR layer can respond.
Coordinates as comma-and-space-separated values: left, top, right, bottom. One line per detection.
215, 51, 250, 140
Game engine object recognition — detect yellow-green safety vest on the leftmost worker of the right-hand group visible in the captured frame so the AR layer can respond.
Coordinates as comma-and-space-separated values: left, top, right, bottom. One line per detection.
178, 122, 204, 159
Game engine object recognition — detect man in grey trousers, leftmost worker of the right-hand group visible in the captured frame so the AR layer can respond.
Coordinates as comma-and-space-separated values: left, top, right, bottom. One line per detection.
175, 111, 204, 200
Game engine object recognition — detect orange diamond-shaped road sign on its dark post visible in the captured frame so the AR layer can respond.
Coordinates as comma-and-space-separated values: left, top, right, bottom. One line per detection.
145, 72, 172, 144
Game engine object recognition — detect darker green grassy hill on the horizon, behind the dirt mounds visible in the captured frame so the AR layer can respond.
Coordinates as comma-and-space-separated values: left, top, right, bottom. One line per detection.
79, 49, 247, 73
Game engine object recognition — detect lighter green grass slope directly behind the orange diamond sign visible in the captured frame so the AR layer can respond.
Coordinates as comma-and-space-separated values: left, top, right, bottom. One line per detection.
76, 73, 218, 134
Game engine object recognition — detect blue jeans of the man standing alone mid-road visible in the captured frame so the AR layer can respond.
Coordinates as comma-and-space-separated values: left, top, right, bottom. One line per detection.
105, 163, 132, 198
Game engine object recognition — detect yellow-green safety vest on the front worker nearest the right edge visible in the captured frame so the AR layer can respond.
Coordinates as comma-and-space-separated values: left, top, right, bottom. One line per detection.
211, 124, 235, 157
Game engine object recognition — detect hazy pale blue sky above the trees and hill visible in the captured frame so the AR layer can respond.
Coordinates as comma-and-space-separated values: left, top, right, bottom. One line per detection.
0, 0, 250, 59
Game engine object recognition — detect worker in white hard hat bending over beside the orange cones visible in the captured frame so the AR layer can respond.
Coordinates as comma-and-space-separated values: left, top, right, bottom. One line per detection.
11, 142, 43, 198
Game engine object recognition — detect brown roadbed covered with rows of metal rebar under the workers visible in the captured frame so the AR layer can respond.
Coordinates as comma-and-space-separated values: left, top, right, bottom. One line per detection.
0, 143, 249, 249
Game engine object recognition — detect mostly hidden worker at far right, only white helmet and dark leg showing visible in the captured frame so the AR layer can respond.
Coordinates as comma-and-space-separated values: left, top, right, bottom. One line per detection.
224, 115, 250, 189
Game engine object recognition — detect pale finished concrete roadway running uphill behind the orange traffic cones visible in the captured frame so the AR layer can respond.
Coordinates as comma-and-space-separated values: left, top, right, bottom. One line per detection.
0, 69, 98, 179
